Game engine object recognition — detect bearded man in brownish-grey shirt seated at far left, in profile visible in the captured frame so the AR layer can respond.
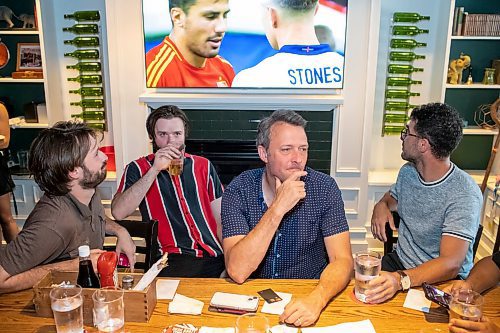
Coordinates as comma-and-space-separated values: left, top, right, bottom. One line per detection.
0, 122, 135, 293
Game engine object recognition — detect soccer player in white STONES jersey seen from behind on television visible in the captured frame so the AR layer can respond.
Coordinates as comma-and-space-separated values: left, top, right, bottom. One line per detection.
232, 0, 344, 88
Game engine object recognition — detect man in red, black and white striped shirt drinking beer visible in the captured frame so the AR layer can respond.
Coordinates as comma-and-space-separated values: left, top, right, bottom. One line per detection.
111, 105, 224, 277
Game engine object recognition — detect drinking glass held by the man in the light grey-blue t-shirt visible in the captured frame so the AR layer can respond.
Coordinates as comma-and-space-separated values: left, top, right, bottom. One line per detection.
354, 251, 381, 303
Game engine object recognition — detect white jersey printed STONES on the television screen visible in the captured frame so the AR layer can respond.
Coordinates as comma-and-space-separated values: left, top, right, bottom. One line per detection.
231, 44, 344, 88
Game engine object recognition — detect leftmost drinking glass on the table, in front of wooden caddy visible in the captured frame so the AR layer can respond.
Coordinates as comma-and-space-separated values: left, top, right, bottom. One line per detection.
49, 285, 83, 333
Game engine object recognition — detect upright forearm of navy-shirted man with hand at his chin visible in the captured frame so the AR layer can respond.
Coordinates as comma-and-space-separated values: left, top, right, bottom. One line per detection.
225, 208, 283, 283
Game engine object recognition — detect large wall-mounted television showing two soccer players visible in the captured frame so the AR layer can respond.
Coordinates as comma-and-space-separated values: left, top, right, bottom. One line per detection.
142, 0, 347, 89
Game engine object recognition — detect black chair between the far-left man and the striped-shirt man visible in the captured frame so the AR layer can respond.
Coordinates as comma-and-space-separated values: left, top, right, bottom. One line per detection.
104, 220, 160, 271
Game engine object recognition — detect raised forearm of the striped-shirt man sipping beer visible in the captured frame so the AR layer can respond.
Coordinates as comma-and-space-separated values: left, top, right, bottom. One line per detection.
111, 168, 158, 220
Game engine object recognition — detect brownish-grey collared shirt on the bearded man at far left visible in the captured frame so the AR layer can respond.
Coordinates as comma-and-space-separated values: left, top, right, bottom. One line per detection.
0, 193, 106, 275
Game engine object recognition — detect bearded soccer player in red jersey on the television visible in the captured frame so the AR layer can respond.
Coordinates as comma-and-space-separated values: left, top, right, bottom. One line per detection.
146, 0, 234, 88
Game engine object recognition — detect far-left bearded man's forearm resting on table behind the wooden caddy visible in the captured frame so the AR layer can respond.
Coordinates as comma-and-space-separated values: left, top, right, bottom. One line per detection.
0, 258, 78, 293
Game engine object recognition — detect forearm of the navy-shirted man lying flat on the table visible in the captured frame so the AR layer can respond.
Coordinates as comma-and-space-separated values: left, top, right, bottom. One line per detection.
311, 258, 353, 308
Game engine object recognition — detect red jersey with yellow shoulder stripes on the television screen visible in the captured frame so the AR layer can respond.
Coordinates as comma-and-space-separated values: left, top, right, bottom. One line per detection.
146, 36, 234, 88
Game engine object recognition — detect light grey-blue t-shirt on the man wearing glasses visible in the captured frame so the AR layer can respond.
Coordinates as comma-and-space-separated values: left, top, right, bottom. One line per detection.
390, 163, 483, 278
